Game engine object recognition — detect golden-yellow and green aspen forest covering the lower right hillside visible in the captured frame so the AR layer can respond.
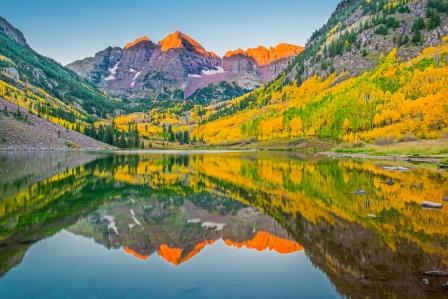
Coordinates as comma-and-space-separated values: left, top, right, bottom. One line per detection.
193, 39, 448, 144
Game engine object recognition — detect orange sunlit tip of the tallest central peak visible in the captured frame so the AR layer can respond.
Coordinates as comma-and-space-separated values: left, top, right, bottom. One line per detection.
159, 30, 217, 57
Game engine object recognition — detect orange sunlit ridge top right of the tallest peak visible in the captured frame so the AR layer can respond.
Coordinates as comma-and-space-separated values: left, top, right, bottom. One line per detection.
224, 43, 303, 66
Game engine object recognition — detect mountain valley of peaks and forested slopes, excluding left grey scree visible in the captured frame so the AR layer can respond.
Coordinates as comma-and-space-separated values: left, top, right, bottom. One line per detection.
0, 0, 448, 155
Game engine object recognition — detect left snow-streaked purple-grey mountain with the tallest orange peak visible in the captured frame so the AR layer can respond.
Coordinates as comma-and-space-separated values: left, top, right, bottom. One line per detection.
68, 31, 220, 99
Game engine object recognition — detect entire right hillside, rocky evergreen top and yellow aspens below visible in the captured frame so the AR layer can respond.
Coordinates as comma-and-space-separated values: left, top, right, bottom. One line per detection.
191, 0, 448, 144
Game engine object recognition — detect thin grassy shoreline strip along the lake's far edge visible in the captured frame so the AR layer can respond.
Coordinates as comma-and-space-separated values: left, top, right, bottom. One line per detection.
0, 138, 448, 165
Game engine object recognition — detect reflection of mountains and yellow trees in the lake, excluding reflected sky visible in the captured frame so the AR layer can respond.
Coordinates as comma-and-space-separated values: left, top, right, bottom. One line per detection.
0, 153, 448, 298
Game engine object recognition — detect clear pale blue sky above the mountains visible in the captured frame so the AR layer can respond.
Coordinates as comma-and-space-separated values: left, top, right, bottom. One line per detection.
0, 0, 339, 64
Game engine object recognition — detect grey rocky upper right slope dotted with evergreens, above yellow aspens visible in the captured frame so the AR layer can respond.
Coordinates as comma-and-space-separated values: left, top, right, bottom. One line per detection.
286, 0, 448, 82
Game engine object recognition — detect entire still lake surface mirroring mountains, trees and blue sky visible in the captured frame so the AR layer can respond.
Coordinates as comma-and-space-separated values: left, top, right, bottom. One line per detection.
0, 152, 448, 298
